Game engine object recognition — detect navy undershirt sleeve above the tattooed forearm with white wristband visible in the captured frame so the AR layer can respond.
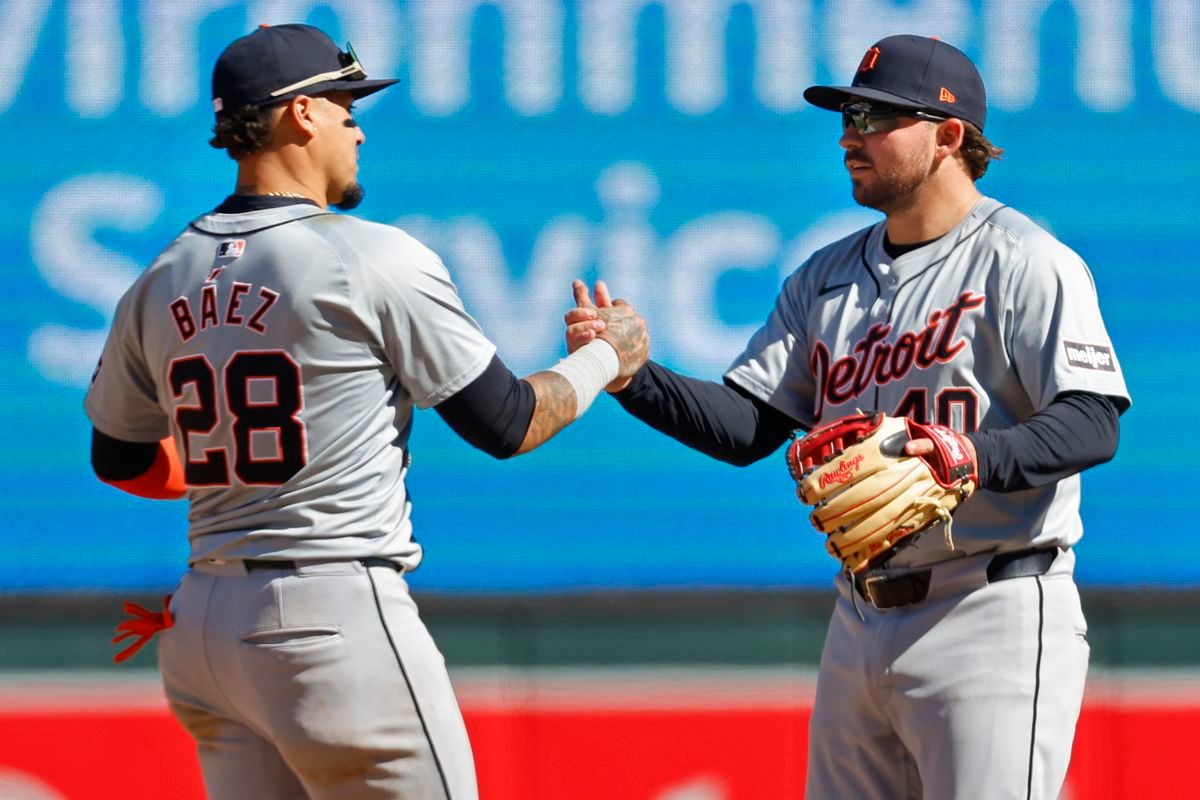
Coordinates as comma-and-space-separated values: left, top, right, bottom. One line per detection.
433, 356, 538, 458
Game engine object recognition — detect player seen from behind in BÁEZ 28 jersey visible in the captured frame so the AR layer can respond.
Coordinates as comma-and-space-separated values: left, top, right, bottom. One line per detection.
85, 25, 647, 800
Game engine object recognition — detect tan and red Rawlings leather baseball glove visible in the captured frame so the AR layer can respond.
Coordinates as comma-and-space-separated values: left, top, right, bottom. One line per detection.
787, 411, 979, 572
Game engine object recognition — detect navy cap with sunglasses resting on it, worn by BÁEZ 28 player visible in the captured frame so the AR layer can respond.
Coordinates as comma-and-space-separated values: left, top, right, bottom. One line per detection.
212, 25, 396, 114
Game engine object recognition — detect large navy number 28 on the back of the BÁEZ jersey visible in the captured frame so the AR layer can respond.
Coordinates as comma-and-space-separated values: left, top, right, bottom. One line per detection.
167, 350, 307, 486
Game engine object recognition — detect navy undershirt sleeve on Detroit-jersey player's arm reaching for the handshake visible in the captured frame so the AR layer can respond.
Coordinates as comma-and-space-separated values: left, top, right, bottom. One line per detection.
613, 361, 799, 467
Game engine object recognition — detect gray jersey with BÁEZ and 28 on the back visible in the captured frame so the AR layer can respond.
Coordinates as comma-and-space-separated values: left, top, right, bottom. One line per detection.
86, 205, 496, 569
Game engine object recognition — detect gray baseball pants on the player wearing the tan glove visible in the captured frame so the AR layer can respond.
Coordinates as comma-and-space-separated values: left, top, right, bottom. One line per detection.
805, 551, 1090, 800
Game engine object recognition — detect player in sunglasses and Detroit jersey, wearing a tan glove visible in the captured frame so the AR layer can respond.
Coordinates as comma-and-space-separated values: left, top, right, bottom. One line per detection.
566, 36, 1129, 800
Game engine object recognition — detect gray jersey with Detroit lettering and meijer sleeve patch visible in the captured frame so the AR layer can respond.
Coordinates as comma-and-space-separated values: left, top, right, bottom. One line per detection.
726, 198, 1128, 565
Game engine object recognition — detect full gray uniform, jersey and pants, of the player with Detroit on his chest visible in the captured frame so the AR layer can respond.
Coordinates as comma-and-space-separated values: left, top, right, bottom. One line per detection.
727, 198, 1128, 800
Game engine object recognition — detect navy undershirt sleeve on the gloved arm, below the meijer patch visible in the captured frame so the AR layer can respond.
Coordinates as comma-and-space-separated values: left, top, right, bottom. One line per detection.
967, 392, 1121, 492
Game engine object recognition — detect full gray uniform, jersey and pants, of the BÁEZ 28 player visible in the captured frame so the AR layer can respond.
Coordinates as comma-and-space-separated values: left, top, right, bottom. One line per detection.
86, 204, 496, 800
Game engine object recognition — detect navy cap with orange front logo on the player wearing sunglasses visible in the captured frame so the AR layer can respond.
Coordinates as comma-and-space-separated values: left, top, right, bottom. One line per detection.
804, 35, 988, 131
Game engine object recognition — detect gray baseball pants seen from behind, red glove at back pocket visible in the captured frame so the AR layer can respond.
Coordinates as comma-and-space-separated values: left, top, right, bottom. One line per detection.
158, 561, 478, 800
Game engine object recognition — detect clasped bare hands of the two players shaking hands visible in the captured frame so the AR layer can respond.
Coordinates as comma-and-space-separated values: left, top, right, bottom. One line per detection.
564, 279, 650, 392
